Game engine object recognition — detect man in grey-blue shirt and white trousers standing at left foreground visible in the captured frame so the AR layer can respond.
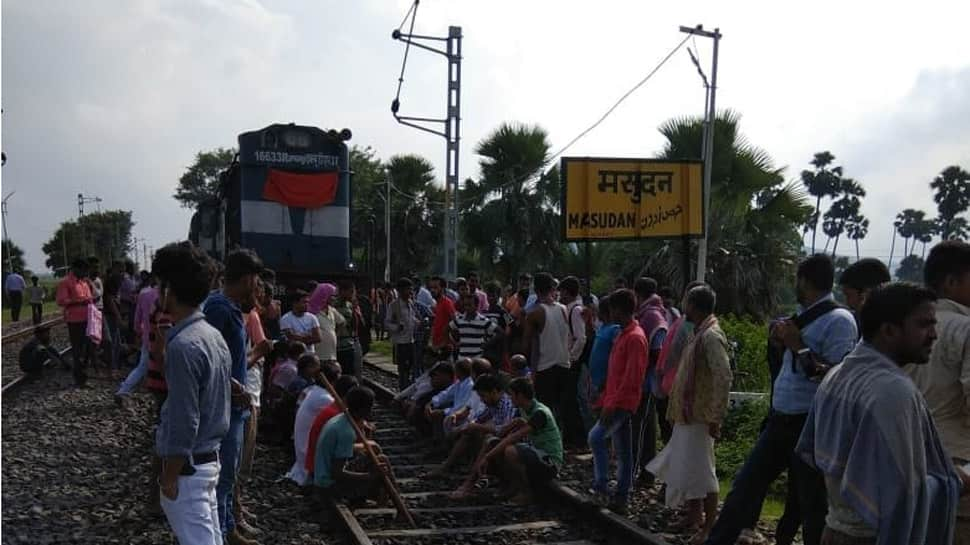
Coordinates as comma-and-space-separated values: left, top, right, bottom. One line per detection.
152, 242, 232, 545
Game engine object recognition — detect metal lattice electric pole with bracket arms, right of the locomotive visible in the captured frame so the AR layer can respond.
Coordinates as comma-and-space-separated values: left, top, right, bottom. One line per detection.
391, 11, 462, 278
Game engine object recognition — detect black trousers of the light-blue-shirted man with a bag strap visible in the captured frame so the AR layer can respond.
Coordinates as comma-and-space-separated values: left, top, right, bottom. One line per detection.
706, 413, 828, 545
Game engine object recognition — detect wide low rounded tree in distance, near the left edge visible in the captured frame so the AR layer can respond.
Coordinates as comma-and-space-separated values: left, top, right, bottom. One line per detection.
41, 210, 136, 276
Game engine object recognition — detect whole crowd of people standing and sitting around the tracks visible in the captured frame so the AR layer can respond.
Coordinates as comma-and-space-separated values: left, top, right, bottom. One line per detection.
17, 237, 970, 545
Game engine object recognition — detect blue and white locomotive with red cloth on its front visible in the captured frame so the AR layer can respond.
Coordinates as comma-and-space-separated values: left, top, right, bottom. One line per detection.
189, 124, 354, 291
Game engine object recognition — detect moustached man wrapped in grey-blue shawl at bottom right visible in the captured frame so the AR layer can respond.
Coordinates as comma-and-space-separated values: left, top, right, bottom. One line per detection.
796, 283, 970, 545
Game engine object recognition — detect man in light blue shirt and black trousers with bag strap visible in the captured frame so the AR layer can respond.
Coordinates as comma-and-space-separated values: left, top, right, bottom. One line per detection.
705, 255, 858, 545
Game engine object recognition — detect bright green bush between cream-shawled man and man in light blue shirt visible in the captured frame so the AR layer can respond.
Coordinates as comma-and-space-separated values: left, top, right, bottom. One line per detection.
718, 314, 771, 393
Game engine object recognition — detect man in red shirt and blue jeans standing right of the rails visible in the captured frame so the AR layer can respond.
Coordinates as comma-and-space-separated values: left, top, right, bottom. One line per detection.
589, 289, 647, 514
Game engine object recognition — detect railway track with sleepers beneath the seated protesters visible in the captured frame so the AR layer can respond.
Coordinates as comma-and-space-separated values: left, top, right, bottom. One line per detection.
335, 364, 667, 545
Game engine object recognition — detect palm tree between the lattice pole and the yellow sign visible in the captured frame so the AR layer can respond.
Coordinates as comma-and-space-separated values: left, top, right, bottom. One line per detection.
459, 123, 562, 278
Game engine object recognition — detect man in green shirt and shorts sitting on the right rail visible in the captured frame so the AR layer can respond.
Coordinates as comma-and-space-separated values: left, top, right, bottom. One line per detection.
473, 378, 563, 505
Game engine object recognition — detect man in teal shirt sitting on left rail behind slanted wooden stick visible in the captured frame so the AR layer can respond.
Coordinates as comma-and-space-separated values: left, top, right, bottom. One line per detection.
313, 387, 390, 505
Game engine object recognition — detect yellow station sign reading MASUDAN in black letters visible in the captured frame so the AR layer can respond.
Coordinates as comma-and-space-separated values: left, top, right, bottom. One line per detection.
561, 157, 704, 241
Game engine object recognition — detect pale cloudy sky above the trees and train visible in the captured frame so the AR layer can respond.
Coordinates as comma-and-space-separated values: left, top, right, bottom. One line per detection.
0, 0, 970, 271
